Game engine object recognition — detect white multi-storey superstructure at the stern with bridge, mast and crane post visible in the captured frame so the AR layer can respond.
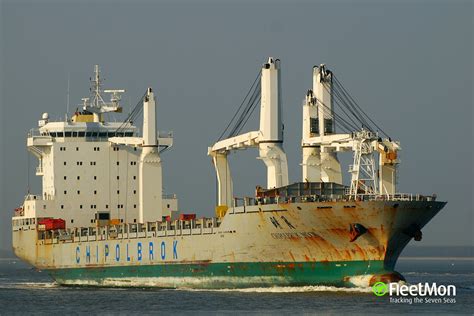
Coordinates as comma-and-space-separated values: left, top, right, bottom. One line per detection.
23, 66, 177, 226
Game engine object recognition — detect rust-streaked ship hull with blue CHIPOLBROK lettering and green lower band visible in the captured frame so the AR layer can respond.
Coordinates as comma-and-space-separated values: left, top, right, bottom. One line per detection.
13, 201, 445, 288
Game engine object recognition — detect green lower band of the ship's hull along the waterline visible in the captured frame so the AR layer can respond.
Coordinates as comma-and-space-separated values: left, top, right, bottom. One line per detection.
48, 261, 391, 288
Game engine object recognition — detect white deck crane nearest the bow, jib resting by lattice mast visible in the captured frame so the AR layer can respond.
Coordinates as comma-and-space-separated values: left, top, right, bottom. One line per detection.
301, 65, 400, 199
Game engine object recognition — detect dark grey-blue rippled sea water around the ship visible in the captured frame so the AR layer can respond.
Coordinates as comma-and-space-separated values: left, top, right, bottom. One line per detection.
0, 258, 474, 315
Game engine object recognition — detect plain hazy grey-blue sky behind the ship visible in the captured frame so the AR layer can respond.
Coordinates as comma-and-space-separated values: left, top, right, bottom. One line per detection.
0, 0, 474, 249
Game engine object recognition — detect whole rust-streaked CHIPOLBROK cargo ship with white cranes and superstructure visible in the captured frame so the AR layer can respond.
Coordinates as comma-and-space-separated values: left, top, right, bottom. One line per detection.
12, 57, 446, 288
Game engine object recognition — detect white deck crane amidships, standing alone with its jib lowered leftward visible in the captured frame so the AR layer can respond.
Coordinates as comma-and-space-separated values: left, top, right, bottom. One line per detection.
208, 57, 288, 212
